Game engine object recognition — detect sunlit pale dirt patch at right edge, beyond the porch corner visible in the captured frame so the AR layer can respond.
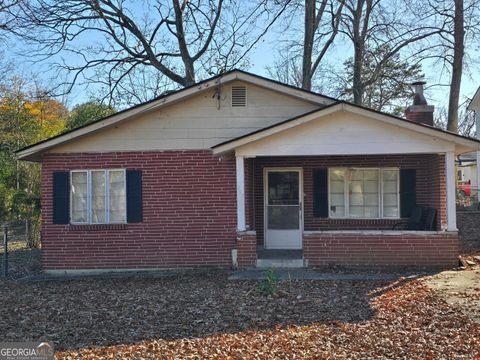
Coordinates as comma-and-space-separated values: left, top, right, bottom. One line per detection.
426, 265, 480, 323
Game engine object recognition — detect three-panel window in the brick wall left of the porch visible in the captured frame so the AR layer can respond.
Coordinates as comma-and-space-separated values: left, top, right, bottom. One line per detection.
70, 169, 126, 224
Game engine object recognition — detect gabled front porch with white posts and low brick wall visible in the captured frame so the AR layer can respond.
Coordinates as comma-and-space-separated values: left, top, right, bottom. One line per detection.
214, 104, 478, 268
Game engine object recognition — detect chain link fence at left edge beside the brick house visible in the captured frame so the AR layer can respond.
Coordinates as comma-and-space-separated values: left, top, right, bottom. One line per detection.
0, 219, 41, 279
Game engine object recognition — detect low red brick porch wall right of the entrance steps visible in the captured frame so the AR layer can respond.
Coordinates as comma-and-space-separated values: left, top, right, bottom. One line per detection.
303, 232, 458, 267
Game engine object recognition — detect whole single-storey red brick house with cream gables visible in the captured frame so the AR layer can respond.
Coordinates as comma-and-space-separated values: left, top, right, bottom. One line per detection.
18, 70, 480, 273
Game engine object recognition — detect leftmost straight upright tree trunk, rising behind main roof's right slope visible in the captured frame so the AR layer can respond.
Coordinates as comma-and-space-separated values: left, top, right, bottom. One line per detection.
302, 0, 316, 90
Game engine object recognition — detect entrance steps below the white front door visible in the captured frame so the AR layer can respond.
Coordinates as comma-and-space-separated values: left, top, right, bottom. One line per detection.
256, 246, 305, 269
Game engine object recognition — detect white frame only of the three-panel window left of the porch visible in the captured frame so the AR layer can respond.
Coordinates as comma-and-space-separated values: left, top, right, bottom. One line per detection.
70, 169, 127, 225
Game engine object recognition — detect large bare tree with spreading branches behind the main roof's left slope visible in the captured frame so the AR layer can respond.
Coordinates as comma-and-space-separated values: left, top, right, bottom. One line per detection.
15, 0, 284, 101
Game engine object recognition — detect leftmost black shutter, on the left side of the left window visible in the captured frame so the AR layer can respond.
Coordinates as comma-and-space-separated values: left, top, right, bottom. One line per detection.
53, 172, 70, 224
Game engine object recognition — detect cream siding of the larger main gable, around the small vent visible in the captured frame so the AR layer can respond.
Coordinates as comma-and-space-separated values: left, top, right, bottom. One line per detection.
51, 81, 320, 153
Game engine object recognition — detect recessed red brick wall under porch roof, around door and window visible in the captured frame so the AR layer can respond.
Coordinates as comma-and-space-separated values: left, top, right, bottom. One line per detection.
252, 154, 446, 244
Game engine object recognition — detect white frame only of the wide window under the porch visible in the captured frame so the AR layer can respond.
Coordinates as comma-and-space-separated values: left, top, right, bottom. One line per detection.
328, 167, 400, 220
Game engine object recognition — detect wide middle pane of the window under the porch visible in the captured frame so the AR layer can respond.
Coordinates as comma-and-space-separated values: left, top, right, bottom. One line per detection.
348, 169, 380, 218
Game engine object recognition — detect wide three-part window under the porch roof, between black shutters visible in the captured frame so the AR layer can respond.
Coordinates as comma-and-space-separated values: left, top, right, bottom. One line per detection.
329, 168, 400, 219
